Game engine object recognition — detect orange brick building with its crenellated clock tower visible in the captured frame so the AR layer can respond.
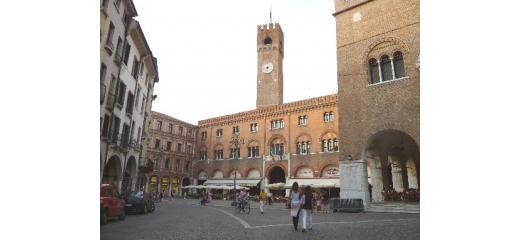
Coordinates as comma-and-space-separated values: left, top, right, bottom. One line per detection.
194, 23, 340, 195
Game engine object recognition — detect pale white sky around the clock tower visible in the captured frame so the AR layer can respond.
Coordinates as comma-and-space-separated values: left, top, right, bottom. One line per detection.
134, 0, 337, 124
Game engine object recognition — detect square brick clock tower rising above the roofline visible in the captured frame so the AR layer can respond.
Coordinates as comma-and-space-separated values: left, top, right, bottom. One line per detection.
256, 23, 284, 108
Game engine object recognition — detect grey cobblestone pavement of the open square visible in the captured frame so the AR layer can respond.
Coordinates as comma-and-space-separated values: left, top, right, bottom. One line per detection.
101, 199, 419, 240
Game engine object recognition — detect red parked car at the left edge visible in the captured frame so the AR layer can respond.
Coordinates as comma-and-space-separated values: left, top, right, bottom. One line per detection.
100, 184, 126, 225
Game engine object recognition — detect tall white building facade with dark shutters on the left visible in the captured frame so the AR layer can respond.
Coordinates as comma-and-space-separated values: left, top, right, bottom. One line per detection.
100, 0, 159, 192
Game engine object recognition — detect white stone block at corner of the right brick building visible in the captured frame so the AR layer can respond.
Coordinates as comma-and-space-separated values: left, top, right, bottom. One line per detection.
339, 159, 370, 209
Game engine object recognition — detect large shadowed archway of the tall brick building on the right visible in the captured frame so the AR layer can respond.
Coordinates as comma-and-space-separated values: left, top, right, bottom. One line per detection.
363, 129, 420, 202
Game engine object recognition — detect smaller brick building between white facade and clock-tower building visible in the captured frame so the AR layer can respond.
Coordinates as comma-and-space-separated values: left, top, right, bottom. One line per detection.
145, 112, 197, 194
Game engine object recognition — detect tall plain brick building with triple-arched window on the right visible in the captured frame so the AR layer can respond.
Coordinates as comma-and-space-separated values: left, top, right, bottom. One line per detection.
333, 0, 420, 202
